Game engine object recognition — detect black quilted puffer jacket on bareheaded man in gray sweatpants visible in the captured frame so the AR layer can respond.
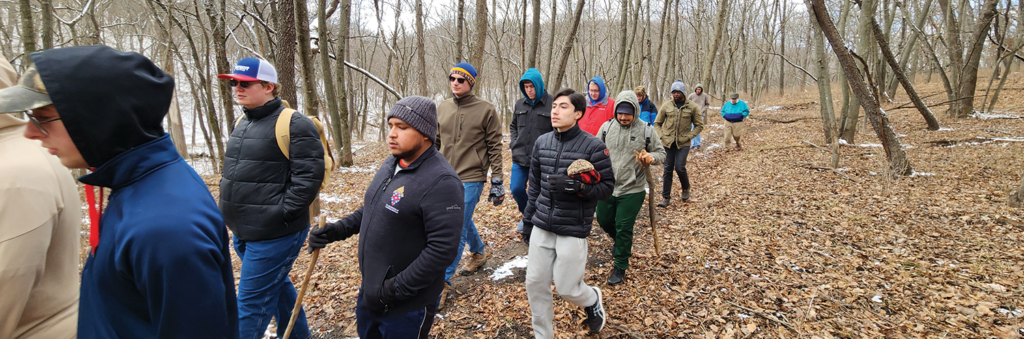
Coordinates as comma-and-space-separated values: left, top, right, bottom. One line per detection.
523, 125, 615, 238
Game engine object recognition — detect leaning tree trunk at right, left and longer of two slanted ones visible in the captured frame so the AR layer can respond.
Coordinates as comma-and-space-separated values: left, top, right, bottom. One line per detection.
810, 0, 913, 175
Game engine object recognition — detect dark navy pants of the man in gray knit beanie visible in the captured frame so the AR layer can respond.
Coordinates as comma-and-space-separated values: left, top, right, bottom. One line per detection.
355, 291, 437, 339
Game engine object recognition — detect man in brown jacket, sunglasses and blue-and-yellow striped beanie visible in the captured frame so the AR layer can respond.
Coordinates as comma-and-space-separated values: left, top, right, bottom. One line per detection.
436, 62, 505, 307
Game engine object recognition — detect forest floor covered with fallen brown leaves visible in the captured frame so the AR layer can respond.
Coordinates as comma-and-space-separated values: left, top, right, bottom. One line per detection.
74, 73, 1024, 338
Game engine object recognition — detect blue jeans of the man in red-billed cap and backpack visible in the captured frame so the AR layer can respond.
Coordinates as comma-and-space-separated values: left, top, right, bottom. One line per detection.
233, 226, 309, 339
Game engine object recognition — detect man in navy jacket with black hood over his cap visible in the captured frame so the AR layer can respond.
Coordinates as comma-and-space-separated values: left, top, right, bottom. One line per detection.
9, 46, 239, 339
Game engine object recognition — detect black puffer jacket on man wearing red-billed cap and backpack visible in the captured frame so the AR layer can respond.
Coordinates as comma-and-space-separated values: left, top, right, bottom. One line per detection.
220, 98, 324, 241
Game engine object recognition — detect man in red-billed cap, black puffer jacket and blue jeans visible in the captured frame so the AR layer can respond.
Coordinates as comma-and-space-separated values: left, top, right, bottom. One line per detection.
217, 57, 325, 339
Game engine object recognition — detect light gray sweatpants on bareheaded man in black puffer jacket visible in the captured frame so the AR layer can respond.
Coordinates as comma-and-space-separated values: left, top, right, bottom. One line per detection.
526, 227, 597, 339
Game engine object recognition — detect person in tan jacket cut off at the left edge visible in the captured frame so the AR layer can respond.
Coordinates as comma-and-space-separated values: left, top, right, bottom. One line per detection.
0, 55, 82, 339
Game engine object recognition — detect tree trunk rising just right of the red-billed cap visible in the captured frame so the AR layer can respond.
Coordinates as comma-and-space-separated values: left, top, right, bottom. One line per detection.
274, 0, 296, 104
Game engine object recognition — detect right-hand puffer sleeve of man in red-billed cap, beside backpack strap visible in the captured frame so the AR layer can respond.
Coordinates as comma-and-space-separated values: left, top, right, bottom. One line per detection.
284, 112, 324, 221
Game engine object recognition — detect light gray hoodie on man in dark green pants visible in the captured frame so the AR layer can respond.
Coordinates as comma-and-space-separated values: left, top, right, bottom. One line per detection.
597, 90, 666, 197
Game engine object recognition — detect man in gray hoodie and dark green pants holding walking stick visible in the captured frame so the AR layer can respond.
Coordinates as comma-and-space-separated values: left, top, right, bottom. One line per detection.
596, 91, 666, 285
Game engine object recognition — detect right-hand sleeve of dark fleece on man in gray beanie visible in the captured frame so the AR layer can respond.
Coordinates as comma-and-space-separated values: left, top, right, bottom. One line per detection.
394, 175, 466, 301
